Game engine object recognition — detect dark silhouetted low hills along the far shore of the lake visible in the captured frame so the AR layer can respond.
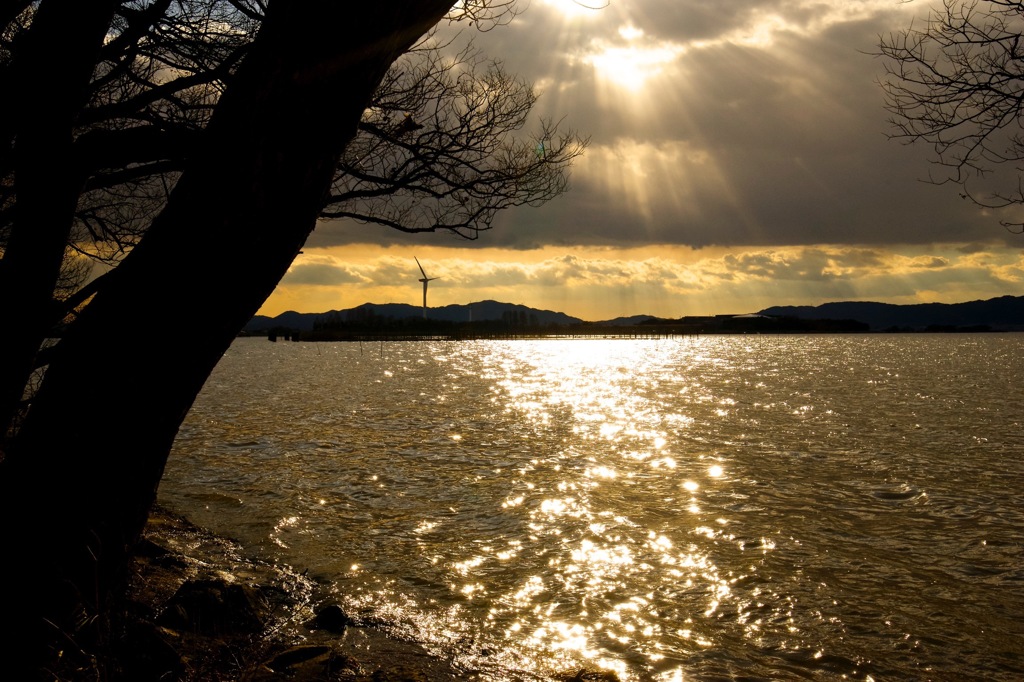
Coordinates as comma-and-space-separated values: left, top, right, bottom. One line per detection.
245, 296, 1024, 334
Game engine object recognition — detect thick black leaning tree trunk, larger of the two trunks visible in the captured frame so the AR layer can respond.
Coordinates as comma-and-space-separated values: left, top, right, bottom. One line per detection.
0, 0, 452, 679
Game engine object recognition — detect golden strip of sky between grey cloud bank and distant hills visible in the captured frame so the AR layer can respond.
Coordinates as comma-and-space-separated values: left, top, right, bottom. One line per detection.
262, 244, 1024, 321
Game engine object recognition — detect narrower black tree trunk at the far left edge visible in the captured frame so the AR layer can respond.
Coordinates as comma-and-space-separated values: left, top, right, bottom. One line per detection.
0, 0, 119, 441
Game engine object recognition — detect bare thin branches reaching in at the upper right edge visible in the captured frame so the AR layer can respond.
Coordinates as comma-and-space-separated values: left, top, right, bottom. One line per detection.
881, 0, 1024, 231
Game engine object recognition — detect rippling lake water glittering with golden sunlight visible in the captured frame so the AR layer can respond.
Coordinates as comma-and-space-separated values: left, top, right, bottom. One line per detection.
160, 334, 1024, 681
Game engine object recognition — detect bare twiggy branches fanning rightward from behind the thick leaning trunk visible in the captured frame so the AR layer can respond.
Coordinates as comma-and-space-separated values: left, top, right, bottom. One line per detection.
322, 39, 587, 239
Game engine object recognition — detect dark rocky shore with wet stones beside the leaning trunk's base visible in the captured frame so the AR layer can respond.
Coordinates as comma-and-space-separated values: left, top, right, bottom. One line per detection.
116, 509, 616, 682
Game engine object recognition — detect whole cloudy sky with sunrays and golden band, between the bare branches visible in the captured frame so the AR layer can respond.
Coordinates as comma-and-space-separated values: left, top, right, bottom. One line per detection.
260, 0, 1024, 321
